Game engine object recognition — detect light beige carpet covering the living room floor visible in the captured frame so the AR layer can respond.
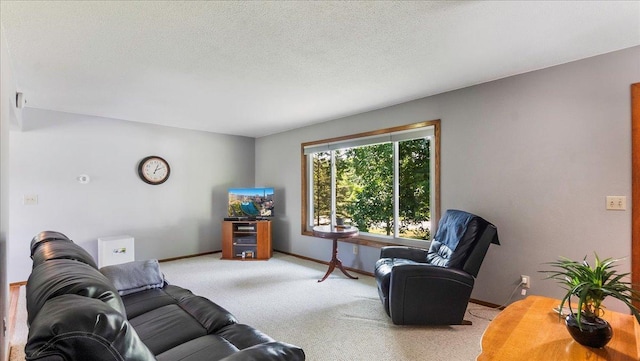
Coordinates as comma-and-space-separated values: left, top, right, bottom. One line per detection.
11, 252, 498, 361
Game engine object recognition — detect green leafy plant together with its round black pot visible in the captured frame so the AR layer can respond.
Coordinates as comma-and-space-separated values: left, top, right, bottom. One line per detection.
542, 254, 640, 348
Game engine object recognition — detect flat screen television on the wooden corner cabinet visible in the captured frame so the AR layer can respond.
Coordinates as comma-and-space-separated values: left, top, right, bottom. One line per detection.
228, 188, 274, 218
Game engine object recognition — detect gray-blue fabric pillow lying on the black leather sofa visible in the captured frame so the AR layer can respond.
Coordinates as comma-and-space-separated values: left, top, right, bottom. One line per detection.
100, 259, 164, 295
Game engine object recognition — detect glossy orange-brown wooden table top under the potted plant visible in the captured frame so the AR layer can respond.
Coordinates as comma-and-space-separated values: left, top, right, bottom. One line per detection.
477, 296, 640, 361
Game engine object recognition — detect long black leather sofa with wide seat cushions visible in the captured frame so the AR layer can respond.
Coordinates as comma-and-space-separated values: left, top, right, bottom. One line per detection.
25, 231, 305, 361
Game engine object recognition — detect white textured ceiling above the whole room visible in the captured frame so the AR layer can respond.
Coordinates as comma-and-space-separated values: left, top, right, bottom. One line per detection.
0, 0, 640, 137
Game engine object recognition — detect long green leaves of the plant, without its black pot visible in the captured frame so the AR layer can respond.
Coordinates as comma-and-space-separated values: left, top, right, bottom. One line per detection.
541, 254, 640, 329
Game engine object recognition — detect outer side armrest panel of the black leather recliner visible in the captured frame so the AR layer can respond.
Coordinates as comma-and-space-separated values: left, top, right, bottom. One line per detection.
389, 264, 474, 325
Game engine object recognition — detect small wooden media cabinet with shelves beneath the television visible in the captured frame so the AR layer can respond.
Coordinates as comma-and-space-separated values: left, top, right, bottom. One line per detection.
222, 220, 273, 260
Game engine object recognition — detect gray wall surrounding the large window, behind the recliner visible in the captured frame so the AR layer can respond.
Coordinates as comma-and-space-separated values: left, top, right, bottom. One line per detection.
256, 47, 640, 308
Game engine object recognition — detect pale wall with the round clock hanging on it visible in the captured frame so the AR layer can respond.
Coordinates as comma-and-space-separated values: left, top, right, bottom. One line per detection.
9, 108, 255, 282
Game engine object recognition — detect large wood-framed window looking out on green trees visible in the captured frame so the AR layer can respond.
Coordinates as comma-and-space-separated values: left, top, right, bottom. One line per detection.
302, 120, 440, 245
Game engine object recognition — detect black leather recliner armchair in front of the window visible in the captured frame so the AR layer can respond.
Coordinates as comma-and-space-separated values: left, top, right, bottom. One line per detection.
375, 210, 500, 325
